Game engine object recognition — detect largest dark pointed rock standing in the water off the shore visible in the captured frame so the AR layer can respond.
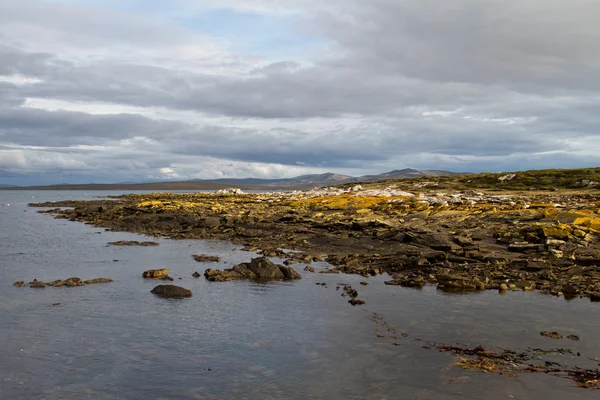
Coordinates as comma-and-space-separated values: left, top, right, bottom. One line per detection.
204, 257, 302, 282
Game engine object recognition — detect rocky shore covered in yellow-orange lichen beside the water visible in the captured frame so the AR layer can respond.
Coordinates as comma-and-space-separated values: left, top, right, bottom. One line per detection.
31, 176, 600, 301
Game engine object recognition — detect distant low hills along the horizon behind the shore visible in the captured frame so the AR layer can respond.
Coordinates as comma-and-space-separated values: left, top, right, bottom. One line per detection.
0, 168, 456, 190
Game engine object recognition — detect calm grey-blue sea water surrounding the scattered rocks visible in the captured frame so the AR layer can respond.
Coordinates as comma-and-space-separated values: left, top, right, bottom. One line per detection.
0, 191, 600, 399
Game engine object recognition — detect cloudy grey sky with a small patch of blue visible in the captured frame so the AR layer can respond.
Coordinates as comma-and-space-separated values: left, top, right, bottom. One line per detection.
0, 0, 600, 185
